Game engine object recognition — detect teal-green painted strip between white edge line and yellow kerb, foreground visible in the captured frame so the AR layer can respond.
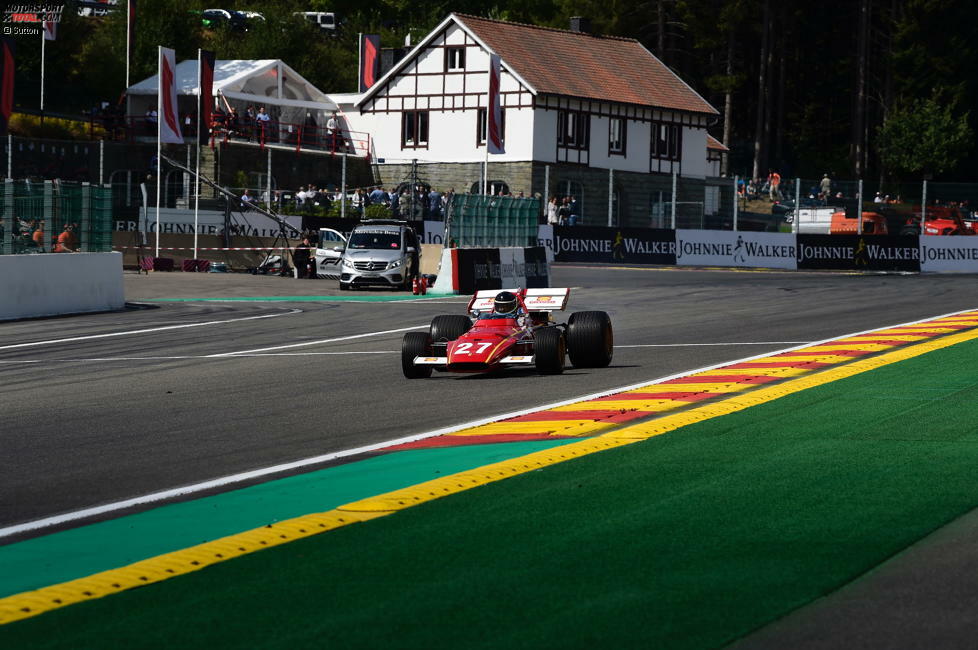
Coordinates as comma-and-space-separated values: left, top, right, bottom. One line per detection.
0, 439, 573, 597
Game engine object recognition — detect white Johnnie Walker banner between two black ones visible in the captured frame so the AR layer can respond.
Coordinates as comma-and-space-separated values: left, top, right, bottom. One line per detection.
676, 230, 796, 269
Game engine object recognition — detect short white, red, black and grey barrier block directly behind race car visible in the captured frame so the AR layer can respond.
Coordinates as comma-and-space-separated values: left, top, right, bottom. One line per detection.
429, 246, 550, 295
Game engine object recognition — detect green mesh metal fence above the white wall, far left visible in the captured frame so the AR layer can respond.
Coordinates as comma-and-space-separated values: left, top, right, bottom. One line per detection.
0, 179, 112, 255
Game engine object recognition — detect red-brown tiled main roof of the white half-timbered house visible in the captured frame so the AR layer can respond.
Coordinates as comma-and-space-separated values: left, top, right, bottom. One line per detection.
453, 14, 717, 115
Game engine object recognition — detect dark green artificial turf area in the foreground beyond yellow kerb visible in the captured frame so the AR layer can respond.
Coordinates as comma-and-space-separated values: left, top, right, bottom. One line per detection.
0, 342, 978, 649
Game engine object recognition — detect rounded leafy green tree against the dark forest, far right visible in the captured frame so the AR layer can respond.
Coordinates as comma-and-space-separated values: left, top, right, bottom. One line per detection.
879, 97, 972, 176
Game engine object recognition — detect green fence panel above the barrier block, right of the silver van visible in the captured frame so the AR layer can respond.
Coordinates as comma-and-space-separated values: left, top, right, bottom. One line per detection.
446, 194, 540, 248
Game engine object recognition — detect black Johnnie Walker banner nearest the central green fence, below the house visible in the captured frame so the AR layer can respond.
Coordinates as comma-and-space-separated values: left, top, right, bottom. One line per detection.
553, 226, 676, 264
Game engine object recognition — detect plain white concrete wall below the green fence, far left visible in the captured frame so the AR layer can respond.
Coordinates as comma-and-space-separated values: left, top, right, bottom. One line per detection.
0, 253, 126, 321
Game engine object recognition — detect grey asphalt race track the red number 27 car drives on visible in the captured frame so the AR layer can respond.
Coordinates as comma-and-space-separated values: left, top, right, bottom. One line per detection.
0, 267, 975, 644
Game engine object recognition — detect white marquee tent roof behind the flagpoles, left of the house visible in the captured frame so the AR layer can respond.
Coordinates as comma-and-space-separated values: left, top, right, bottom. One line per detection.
127, 59, 337, 136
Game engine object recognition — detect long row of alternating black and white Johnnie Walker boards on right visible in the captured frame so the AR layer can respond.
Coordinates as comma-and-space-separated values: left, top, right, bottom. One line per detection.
540, 226, 978, 273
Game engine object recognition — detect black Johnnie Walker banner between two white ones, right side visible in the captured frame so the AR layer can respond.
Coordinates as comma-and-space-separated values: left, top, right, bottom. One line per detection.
797, 235, 920, 272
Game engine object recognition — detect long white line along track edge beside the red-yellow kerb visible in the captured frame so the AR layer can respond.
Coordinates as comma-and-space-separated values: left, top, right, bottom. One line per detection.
0, 308, 975, 538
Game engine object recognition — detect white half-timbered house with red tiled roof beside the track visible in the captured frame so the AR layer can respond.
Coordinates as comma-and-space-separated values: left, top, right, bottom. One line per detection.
345, 14, 722, 225
